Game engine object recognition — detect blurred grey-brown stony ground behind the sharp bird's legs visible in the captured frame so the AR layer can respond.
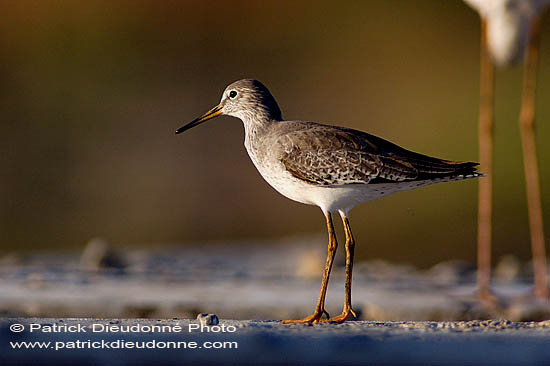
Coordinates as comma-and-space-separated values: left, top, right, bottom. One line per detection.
4, 238, 550, 321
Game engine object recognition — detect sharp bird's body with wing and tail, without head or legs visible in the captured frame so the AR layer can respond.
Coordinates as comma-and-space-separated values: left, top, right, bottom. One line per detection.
245, 121, 479, 212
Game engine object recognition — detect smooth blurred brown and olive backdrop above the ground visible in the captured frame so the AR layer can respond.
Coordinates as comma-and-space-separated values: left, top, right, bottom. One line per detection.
0, 0, 550, 268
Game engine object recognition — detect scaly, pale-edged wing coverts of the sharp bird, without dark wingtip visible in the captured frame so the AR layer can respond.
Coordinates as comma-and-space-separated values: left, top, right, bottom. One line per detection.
278, 126, 418, 186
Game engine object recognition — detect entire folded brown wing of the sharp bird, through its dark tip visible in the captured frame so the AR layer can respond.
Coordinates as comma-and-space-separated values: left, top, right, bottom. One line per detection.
277, 126, 477, 186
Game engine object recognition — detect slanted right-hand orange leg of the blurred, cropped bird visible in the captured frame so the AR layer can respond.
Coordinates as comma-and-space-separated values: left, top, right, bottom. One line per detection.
519, 19, 548, 300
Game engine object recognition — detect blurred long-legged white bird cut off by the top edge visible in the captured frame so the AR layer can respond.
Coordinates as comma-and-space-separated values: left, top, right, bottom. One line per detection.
464, 0, 550, 303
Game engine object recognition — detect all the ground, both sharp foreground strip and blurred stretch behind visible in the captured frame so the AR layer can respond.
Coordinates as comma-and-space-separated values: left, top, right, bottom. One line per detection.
0, 238, 550, 365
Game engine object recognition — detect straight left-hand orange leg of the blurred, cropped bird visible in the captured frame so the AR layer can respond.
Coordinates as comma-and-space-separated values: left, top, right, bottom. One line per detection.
477, 19, 495, 305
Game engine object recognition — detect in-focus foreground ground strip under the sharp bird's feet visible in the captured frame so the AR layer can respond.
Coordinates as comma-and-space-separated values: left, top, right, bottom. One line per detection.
0, 318, 550, 365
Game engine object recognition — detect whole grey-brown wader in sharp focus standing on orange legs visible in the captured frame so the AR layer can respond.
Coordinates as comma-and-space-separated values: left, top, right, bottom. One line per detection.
176, 79, 481, 323
